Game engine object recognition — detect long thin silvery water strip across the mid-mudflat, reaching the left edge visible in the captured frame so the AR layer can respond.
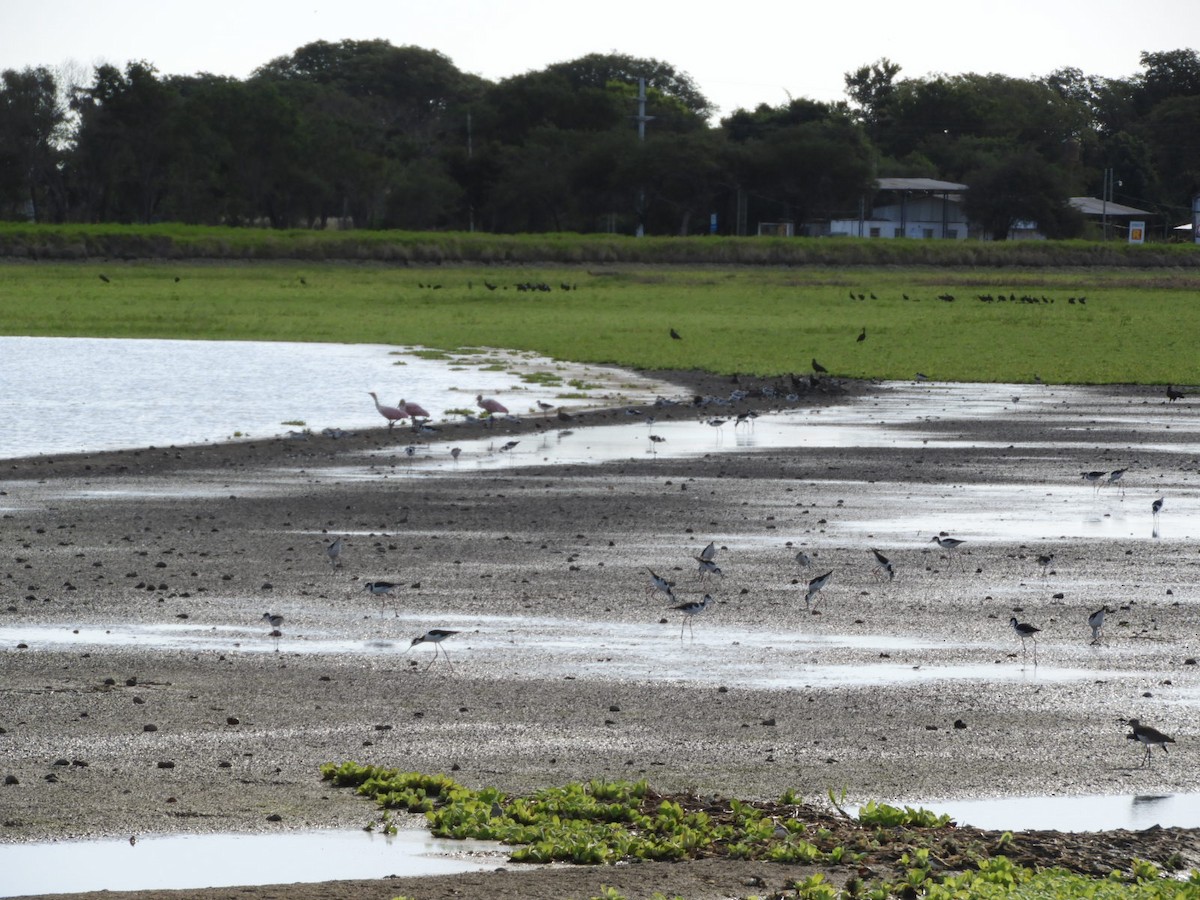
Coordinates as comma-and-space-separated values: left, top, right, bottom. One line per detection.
0, 612, 1139, 690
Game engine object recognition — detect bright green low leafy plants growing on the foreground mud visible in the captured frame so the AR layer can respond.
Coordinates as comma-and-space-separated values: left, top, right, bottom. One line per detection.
320, 762, 1200, 900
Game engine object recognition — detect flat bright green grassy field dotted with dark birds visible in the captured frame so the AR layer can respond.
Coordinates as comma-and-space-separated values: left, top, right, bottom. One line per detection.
0, 260, 1200, 385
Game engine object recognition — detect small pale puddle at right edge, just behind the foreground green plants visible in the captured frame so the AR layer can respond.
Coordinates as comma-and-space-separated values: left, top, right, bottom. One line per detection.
908, 793, 1200, 832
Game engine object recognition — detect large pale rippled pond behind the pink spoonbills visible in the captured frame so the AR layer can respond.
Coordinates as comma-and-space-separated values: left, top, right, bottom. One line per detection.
0, 337, 666, 458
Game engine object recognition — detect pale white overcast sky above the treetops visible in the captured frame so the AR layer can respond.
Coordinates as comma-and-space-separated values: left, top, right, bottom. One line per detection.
0, 0, 1200, 114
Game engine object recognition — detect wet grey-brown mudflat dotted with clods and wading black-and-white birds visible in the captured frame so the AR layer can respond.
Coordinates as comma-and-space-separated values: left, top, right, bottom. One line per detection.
0, 372, 1200, 900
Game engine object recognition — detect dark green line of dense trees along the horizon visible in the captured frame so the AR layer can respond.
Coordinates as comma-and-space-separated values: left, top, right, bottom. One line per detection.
0, 40, 1200, 236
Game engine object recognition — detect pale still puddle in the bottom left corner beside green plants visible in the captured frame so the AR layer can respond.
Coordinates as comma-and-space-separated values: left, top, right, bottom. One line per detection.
0, 829, 502, 896
